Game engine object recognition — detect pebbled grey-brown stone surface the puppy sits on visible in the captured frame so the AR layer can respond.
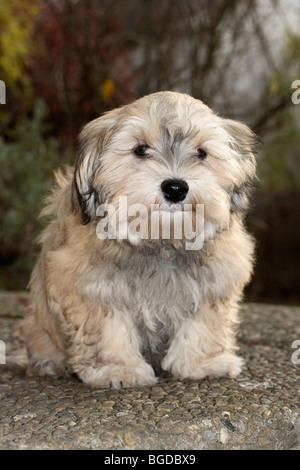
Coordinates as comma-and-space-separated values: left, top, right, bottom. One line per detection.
0, 293, 300, 450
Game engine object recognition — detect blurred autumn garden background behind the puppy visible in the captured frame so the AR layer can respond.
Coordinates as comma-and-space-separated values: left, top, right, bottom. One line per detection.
0, 0, 300, 304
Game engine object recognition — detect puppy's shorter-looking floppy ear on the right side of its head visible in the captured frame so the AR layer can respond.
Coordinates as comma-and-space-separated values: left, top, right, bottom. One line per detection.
223, 119, 258, 214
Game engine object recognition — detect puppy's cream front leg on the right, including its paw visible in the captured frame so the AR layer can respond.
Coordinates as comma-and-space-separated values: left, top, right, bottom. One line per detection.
162, 305, 243, 379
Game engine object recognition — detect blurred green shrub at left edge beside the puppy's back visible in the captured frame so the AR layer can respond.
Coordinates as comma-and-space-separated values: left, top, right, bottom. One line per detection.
0, 100, 72, 289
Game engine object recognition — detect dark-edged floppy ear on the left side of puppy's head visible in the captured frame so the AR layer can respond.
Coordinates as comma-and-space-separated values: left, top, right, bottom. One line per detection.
72, 110, 118, 225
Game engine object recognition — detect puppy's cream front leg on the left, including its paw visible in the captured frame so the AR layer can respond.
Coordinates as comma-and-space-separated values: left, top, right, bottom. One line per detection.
69, 304, 156, 389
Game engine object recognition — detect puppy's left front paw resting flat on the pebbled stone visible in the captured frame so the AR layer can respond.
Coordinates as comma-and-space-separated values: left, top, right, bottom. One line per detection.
78, 364, 157, 389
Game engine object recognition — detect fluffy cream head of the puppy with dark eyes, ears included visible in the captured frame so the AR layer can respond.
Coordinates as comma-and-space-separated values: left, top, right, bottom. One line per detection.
73, 92, 255, 246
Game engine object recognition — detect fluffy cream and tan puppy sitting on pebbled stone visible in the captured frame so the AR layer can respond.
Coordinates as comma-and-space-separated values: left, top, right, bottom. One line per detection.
23, 92, 255, 388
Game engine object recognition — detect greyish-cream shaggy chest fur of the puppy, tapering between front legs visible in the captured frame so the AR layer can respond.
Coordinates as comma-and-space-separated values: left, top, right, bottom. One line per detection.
85, 244, 206, 368
